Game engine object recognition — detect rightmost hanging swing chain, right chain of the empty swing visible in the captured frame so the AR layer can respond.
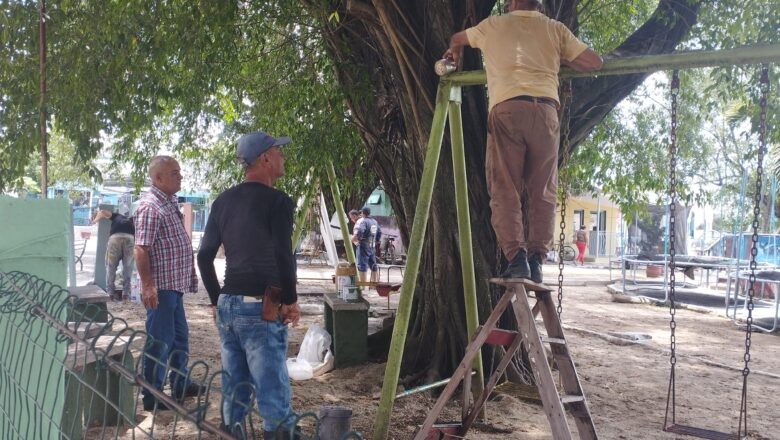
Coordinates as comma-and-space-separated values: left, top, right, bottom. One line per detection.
742, 64, 769, 377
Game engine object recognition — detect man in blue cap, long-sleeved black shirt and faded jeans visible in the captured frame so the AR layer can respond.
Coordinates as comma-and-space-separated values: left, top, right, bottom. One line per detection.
198, 131, 300, 439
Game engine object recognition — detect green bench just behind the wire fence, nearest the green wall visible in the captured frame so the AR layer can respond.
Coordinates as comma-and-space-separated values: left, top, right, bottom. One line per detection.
60, 336, 135, 440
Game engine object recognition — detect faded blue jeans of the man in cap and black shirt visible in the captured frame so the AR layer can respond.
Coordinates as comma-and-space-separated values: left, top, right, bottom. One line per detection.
217, 294, 293, 431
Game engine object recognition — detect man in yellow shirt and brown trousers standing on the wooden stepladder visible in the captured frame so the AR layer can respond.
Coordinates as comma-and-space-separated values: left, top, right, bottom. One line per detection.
444, 0, 602, 283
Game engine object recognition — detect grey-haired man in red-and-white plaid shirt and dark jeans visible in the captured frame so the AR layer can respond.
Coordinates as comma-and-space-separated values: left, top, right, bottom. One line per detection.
133, 156, 204, 411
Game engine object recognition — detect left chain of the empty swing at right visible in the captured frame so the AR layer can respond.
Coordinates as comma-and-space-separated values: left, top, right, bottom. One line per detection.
669, 70, 680, 367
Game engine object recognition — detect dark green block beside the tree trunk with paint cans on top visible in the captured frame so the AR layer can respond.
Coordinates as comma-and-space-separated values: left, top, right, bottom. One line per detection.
324, 292, 369, 368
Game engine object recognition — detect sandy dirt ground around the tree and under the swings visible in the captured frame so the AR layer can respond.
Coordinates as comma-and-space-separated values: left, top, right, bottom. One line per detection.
109, 266, 780, 440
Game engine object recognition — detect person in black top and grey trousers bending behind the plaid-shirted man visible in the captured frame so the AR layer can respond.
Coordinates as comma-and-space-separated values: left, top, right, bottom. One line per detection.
92, 209, 135, 300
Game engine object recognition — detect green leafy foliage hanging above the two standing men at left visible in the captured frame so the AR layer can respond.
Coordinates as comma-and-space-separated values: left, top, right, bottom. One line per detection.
0, 0, 368, 199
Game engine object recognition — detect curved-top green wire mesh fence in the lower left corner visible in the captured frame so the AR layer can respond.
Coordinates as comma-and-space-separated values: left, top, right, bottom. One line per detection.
0, 272, 361, 440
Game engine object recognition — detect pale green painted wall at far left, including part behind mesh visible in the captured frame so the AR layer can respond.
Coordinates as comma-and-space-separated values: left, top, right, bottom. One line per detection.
0, 196, 71, 439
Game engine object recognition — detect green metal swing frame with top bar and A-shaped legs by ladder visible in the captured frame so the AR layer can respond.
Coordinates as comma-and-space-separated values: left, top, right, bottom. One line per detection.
373, 44, 780, 440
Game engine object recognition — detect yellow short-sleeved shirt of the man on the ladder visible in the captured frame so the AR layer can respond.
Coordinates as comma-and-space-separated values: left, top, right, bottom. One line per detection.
466, 11, 588, 109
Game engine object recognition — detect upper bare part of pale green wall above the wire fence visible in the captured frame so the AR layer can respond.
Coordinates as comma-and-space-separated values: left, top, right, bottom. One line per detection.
0, 196, 71, 286
